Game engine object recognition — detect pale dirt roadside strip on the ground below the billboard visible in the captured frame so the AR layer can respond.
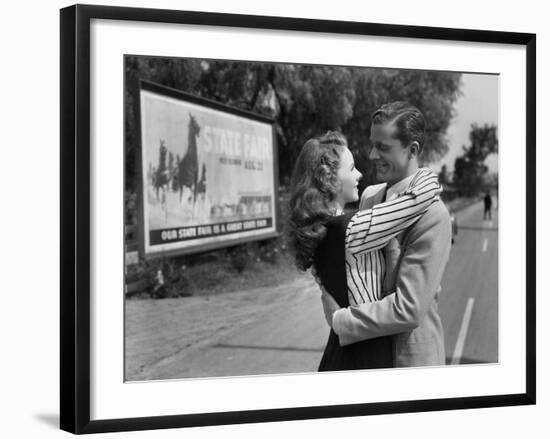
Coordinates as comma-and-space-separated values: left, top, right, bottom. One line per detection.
124, 274, 317, 380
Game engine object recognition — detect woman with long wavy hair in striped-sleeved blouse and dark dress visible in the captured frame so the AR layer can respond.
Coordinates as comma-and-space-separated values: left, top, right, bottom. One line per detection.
288, 131, 441, 371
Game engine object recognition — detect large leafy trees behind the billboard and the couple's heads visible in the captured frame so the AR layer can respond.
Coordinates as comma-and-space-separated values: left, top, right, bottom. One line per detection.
125, 56, 461, 203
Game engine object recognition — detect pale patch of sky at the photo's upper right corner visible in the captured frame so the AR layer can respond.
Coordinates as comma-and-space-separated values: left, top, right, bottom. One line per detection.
431, 73, 499, 172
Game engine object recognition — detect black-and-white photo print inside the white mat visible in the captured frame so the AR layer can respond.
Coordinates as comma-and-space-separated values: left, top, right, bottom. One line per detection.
125, 55, 499, 380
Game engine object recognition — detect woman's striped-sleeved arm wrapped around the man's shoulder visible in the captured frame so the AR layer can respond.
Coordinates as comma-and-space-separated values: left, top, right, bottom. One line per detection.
346, 168, 441, 255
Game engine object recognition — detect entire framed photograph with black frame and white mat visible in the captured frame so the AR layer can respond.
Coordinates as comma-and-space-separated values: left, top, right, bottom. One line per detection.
60, 5, 536, 434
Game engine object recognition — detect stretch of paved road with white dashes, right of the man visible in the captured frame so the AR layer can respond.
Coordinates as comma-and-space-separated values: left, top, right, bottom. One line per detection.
440, 203, 498, 364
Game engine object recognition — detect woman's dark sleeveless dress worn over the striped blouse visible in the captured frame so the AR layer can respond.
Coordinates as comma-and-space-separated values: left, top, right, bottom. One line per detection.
313, 212, 393, 372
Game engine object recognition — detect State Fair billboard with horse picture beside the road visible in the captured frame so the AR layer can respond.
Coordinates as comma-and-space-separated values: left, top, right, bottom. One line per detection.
139, 81, 277, 256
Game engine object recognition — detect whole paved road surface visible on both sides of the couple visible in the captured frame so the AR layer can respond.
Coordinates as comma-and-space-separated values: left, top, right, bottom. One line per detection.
139, 203, 498, 379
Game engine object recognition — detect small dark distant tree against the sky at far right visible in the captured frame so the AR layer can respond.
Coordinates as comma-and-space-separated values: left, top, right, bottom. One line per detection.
454, 124, 498, 196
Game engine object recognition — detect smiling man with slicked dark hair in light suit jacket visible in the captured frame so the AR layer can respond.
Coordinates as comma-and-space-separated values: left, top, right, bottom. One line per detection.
322, 102, 451, 367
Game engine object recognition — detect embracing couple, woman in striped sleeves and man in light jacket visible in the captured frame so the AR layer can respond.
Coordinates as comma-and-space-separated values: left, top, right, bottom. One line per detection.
289, 102, 451, 371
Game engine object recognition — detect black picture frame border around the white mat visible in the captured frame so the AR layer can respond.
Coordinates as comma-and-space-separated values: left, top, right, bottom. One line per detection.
60, 5, 536, 434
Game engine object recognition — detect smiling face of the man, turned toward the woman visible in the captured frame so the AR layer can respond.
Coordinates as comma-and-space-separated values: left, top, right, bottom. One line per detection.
369, 121, 411, 186
